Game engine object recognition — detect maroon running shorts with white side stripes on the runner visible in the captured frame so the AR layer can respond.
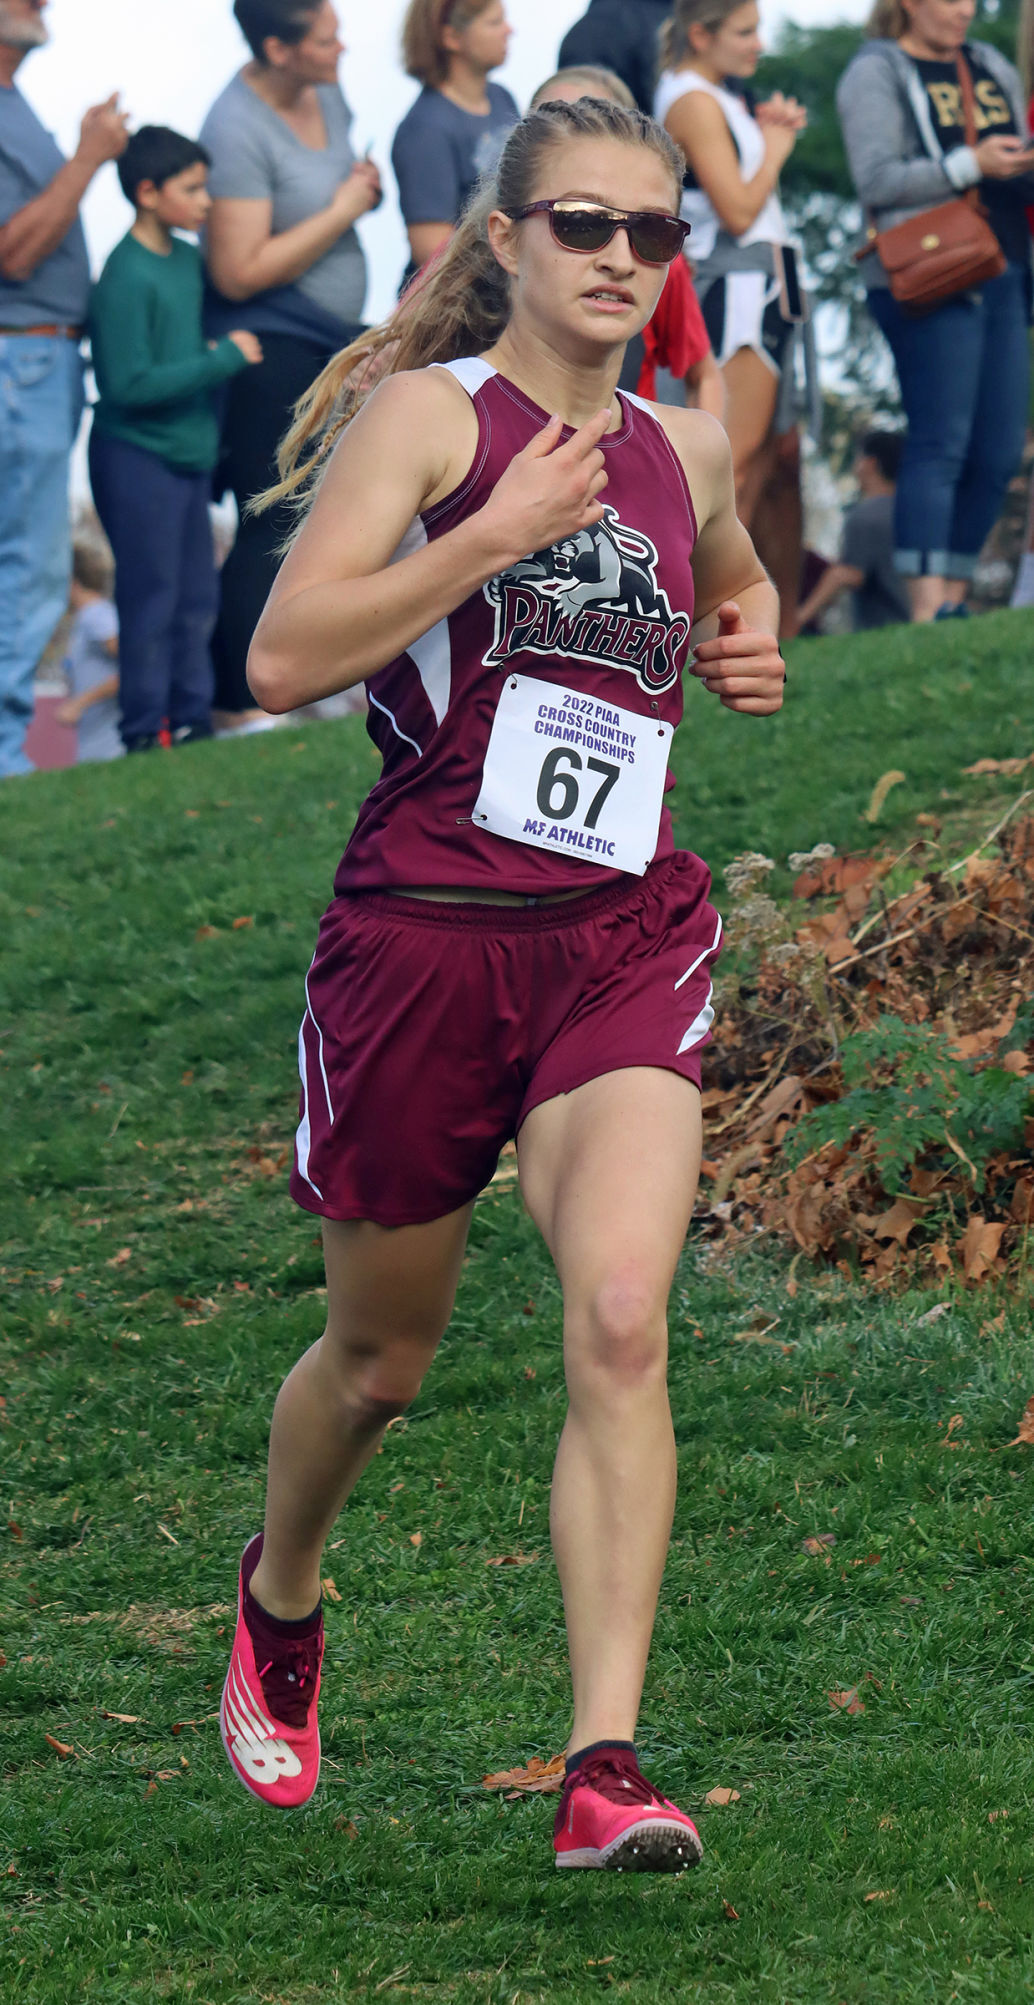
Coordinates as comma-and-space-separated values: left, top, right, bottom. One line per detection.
291, 852, 721, 1225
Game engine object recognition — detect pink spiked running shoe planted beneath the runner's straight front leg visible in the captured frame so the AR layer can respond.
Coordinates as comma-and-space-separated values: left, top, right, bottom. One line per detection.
553, 1748, 703, 1873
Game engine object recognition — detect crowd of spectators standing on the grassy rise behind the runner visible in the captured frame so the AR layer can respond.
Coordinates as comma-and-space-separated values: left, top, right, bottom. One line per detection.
0, 0, 1034, 778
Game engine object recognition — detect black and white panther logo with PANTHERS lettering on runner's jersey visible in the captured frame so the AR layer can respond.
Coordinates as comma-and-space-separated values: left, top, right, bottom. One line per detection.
485, 507, 689, 694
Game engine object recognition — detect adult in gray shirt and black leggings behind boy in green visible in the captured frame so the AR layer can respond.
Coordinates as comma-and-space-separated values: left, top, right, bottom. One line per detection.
202, 0, 381, 728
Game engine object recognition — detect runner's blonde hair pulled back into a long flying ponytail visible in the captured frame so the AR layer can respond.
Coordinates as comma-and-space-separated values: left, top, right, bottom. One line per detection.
262, 98, 685, 511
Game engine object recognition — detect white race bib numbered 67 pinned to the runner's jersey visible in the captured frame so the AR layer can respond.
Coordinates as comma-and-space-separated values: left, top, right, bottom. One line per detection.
473, 676, 673, 876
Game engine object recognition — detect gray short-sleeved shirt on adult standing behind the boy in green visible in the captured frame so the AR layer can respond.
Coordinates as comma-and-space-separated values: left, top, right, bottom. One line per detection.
200, 72, 367, 345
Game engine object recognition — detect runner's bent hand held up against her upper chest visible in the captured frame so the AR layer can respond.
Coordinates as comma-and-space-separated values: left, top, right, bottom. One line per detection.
481, 411, 611, 563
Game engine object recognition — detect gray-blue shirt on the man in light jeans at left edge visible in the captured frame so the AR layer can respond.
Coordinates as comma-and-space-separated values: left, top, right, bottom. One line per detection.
0, 84, 90, 327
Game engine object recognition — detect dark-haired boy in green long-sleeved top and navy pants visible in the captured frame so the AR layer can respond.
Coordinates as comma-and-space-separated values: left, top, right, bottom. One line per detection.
90, 126, 263, 752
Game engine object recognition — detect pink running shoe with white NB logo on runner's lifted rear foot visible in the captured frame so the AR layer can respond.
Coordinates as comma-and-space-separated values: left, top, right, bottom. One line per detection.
218, 1532, 323, 1811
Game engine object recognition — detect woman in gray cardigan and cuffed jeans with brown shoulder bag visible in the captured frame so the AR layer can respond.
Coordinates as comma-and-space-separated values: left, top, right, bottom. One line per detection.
838, 0, 1034, 620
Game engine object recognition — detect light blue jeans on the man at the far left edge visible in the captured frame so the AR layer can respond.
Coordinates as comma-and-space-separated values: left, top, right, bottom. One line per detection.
0, 335, 82, 780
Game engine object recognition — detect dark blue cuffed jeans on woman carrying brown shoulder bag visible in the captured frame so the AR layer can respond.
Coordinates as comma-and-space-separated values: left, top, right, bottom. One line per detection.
870, 265, 1030, 577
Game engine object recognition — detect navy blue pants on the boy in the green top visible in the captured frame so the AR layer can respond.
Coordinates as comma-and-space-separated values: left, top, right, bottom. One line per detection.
90, 425, 218, 746
